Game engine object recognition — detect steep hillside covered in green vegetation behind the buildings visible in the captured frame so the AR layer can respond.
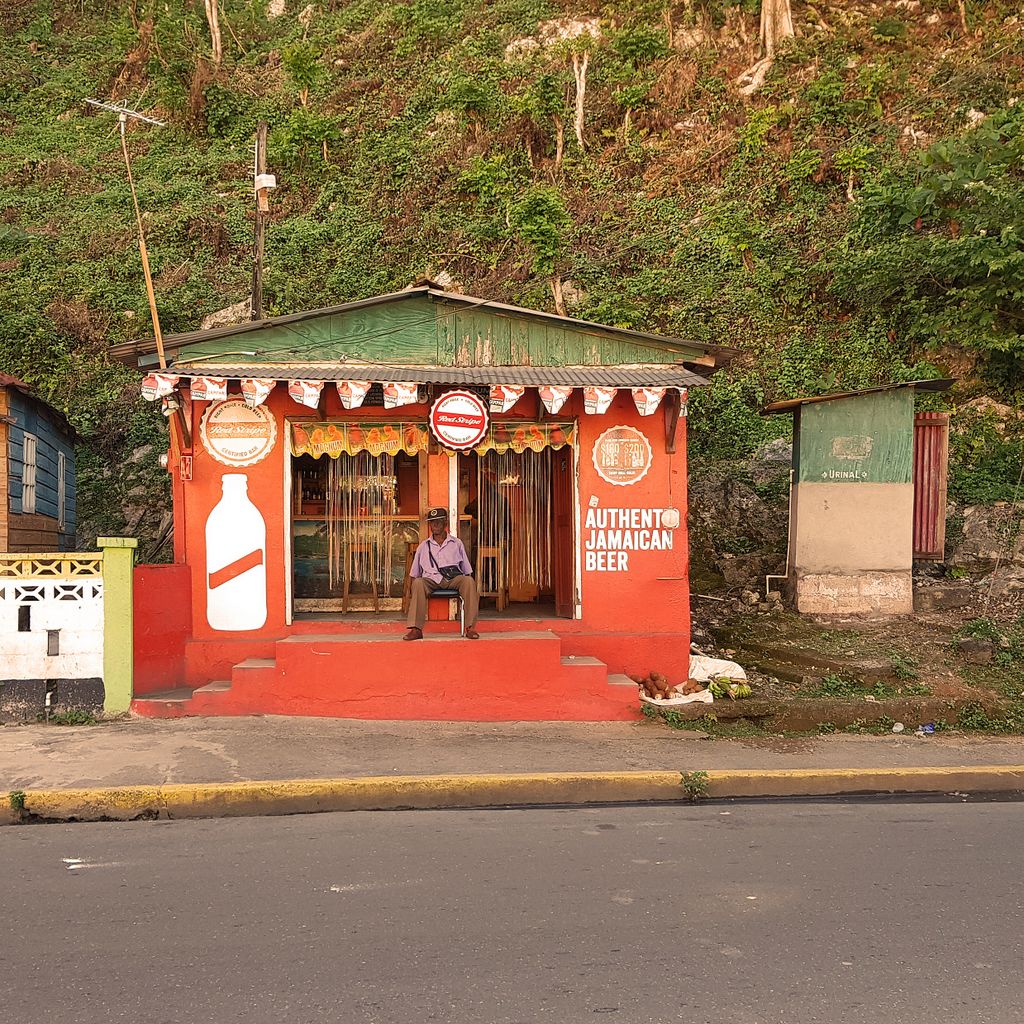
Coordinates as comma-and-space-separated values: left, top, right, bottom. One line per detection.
0, 0, 1024, 551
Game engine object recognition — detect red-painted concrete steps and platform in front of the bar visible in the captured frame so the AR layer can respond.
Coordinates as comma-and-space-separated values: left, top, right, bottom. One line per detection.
132, 630, 638, 722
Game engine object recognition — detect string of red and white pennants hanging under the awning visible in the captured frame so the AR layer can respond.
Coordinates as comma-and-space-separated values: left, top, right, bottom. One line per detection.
142, 373, 686, 416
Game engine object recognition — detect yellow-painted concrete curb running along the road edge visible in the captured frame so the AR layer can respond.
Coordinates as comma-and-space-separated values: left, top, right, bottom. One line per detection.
0, 765, 1024, 824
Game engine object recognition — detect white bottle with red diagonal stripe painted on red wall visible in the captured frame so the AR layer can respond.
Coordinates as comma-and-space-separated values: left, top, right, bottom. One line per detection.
206, 473, 266, 632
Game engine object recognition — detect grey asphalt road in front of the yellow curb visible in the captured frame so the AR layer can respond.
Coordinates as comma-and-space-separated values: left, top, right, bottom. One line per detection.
0, 803, 1024, 1024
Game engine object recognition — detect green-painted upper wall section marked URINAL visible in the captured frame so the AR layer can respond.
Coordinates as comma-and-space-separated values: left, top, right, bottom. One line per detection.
796, 390, 913, 483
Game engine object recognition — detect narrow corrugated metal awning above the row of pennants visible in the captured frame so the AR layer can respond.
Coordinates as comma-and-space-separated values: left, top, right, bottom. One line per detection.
167, 360, 709, 387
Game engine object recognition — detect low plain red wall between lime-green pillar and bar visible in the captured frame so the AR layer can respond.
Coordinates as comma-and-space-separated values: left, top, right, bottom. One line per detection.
133, 565, 191, 696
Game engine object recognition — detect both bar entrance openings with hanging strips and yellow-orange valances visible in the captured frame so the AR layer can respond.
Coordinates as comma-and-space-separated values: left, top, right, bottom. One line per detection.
290, 424, 577, 618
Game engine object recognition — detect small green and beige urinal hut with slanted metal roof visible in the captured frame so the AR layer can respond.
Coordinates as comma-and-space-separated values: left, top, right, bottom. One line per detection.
762, 380, 953, 615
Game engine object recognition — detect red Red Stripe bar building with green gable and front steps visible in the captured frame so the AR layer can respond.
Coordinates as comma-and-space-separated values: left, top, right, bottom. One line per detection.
116, 287, 727, 721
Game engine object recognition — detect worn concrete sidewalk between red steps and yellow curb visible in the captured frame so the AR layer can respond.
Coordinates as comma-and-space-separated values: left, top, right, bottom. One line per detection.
0, 717, 1024, 794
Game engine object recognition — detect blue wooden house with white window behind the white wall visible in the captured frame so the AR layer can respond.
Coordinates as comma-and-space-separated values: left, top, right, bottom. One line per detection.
0, 372, 75, 552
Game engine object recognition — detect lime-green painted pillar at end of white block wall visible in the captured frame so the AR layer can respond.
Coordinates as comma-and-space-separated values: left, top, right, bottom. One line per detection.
96, 537, 138, 715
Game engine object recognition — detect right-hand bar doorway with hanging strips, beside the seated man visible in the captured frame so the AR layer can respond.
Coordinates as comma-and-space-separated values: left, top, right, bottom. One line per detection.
458, 445, 575, 618
